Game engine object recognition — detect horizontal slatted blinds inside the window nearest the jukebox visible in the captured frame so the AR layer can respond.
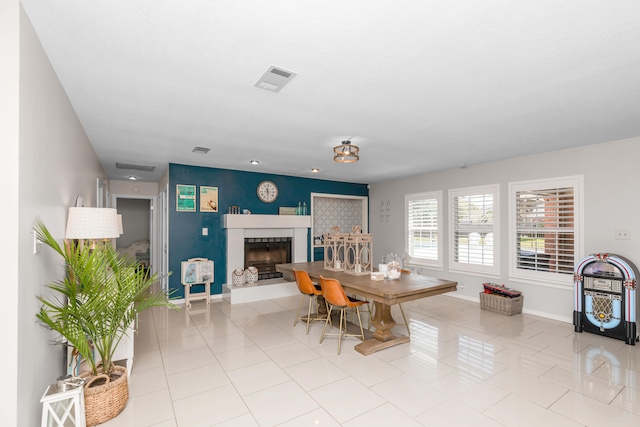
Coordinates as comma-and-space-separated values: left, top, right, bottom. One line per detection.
515, 187, 576, 274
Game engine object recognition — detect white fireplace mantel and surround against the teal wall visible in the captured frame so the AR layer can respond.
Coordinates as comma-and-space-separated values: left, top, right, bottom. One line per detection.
224, 214, 311, 286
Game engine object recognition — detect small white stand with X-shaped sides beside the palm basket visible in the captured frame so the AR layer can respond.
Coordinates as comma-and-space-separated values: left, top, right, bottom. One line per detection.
40, 378, 86, 427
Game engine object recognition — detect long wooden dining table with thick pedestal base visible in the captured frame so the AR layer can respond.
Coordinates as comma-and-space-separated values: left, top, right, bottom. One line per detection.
276, 261, 458, 356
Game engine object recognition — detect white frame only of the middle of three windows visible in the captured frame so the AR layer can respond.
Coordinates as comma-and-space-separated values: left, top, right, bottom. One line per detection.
448, 184, 500, 277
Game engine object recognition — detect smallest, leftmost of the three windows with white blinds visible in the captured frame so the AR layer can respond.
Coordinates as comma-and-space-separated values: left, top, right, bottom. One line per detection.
405, 191, 442, 268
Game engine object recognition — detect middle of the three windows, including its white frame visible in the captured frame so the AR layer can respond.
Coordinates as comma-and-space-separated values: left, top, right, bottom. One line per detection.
449, 184, 500, 274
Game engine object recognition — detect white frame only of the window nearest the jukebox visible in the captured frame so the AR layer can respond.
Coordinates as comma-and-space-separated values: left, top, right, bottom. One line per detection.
509, 175, 584, 289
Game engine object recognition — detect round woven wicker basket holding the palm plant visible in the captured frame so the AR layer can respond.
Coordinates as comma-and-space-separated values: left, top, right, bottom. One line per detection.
80, 366, 129, 427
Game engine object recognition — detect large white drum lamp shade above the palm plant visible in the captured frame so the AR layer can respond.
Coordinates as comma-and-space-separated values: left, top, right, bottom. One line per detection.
64, 207, 120, 239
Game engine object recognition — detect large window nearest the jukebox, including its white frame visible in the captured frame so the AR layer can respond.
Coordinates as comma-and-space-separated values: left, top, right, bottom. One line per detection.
509, 177, 582, 285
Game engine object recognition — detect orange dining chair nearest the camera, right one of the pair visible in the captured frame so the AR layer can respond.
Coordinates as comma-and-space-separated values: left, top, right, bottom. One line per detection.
320, 276, 368, 354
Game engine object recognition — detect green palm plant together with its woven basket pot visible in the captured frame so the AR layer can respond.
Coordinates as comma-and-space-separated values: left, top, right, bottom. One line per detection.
34, 222, 174, 426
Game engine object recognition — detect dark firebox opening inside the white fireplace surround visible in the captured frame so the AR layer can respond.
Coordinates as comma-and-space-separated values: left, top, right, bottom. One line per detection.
244, 237, 291, 280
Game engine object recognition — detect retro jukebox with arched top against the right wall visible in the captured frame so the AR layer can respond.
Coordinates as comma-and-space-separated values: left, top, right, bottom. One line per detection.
573, 254, 640, 345
